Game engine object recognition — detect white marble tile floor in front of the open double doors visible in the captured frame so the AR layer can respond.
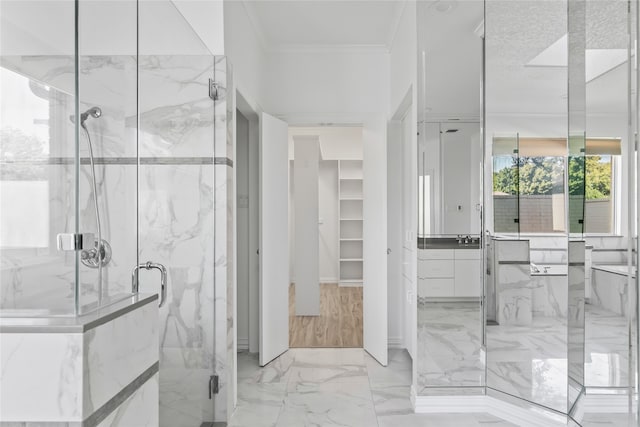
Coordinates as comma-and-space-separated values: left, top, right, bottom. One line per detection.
229, 348, 514, 427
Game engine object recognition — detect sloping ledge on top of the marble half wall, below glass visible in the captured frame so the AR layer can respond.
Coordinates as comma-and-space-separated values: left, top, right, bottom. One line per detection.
0, 294, 158, 334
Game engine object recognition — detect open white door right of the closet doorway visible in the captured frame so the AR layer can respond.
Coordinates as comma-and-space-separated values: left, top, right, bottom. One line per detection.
362, 117, 388, 366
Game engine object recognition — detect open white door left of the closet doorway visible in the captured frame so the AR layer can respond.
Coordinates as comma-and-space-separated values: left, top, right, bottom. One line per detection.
259, 113, 289, 366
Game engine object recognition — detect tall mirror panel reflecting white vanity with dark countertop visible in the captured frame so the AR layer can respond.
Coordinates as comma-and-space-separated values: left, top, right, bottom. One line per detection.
416, 1, 485, 396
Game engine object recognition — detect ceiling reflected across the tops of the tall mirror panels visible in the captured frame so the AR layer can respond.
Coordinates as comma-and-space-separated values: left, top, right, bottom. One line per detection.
418, 0, 627, 121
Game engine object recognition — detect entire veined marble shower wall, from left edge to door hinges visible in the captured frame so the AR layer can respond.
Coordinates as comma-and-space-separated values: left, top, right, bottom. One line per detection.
0, 51, 235, 426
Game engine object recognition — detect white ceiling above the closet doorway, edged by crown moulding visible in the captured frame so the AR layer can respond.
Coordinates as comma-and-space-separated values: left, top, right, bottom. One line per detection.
243, 0, 404, 50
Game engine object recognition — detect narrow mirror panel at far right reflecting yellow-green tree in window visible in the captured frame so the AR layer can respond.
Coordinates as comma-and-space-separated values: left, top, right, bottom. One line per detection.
584, 1, 637, 393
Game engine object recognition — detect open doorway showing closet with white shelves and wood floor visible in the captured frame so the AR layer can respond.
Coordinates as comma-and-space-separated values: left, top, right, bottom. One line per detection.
289, 126, 364, 348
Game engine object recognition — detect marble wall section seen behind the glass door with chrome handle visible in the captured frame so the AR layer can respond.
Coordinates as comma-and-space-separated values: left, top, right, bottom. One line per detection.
138, 55, 234, 427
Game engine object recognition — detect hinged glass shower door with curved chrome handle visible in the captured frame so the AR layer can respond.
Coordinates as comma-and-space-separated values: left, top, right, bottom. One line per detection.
138, 1, 220, 427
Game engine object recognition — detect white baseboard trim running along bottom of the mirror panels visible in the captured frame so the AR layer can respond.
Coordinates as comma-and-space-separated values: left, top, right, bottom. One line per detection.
411, 396, 566, 427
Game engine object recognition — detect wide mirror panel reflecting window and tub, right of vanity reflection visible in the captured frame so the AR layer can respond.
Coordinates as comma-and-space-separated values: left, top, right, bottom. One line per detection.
484, 0, 568, 413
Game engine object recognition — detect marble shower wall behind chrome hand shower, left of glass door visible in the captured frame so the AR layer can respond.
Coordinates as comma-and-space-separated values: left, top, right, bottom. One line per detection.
0, 55, 137, 314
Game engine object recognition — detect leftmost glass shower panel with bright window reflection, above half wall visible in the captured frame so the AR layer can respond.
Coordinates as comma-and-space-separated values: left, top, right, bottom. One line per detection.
0, 1, 77, 317
